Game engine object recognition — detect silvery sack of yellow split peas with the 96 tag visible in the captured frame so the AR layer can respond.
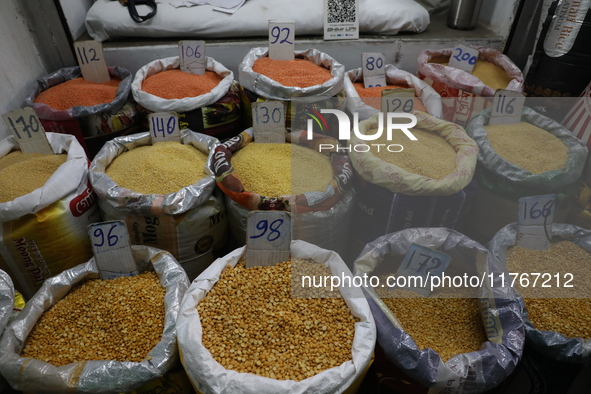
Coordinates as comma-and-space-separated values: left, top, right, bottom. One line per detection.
0, 245, 189, 393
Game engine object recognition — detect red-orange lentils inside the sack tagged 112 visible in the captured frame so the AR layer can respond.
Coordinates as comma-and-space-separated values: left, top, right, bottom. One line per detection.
35, 78, 121, 111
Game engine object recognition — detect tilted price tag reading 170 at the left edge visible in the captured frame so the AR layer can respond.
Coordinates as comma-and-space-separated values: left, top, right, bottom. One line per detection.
2, 107, 53, 155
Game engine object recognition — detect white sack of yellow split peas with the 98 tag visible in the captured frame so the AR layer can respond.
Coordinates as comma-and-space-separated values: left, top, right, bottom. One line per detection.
177, 241, 376, 394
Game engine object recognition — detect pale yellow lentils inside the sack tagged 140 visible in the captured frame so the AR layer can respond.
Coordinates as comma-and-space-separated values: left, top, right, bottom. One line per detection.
105, 141, 207, 194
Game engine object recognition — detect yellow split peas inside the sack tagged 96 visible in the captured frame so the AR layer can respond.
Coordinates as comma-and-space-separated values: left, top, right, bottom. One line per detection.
22, 272, 165, 367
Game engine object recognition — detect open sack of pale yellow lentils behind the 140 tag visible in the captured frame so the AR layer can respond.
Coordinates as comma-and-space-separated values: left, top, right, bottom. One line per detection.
90, 130, 228, 280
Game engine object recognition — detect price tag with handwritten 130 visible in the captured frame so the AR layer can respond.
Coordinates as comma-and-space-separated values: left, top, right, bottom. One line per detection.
252, 100, 286, 143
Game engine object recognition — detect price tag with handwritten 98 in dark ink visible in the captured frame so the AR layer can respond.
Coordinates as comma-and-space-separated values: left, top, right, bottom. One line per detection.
246, 211, 291, 268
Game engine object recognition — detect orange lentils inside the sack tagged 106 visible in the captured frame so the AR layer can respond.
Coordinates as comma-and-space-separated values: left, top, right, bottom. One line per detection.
142, 70, 223, 100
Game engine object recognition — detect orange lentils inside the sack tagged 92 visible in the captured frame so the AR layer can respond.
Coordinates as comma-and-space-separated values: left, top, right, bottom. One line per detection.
252, 57, 332, 88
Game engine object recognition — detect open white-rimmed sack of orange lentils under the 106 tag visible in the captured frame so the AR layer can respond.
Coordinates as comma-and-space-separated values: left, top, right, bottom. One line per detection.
131, 56, 242, 140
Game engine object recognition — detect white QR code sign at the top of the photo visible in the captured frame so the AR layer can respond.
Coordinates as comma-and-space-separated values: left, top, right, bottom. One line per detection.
324, 0, 359, 40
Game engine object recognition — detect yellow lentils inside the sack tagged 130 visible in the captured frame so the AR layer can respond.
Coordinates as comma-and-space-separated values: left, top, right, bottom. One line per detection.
232, 142, 333, 197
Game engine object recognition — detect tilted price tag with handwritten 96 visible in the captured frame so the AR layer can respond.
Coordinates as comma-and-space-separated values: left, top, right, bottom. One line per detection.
87, 220, 139, 279
